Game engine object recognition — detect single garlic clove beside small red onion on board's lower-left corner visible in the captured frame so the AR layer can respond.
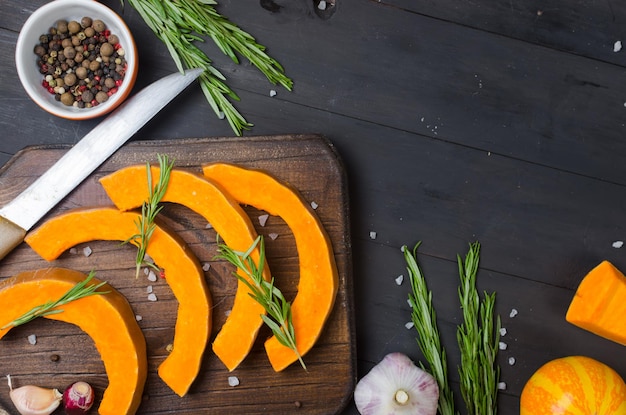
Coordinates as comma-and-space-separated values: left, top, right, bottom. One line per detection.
7, 375, 63, 415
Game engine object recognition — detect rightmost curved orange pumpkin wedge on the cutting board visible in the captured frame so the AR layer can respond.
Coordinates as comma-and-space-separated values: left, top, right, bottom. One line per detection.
203, 163, 338, 372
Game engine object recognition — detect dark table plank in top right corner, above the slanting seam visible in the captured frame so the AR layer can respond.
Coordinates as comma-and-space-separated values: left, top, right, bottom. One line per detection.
381, 0, 626, 66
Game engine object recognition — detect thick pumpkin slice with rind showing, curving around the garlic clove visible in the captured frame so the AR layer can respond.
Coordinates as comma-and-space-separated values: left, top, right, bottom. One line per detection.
0, 268, 148, 415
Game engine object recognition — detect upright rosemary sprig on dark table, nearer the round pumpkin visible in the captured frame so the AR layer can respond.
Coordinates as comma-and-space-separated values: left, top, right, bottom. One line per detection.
450, 242, 500, 415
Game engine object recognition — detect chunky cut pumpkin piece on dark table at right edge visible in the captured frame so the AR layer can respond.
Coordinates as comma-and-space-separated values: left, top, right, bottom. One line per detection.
565, 261, 626, 346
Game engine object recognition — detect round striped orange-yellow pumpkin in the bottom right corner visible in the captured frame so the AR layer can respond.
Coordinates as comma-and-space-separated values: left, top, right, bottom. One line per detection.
520, 356, 626, 415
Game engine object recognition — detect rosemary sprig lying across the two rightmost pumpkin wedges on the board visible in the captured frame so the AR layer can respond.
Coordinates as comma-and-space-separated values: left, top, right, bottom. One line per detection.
217, 236, 306, 370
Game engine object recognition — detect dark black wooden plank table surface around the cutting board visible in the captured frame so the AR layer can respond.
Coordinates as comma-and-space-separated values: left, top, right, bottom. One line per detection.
0, 0, 626, 415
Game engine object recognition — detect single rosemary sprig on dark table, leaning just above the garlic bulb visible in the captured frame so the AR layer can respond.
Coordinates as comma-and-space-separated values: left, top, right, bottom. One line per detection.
402, 242, 458, 415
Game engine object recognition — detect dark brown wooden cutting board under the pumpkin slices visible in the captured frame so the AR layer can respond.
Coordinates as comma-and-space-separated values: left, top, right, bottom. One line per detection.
0, 135, 356, 415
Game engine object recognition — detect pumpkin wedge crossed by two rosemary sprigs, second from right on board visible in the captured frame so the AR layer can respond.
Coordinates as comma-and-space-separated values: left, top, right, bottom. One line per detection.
100, 166, 271, 371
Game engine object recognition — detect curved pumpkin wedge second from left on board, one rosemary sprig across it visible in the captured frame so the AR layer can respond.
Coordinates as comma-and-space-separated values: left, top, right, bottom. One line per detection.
25, 207, 211, 396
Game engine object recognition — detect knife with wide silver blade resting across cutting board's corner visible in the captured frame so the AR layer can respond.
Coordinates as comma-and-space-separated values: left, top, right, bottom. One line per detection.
0, 68, 203, 259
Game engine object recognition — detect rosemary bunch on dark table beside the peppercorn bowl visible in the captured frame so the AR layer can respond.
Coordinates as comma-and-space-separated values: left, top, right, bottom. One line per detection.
122, 0, 293, 135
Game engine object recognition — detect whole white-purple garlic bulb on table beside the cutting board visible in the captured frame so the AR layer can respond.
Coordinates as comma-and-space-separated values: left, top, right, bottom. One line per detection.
354, 353, 439, 415
